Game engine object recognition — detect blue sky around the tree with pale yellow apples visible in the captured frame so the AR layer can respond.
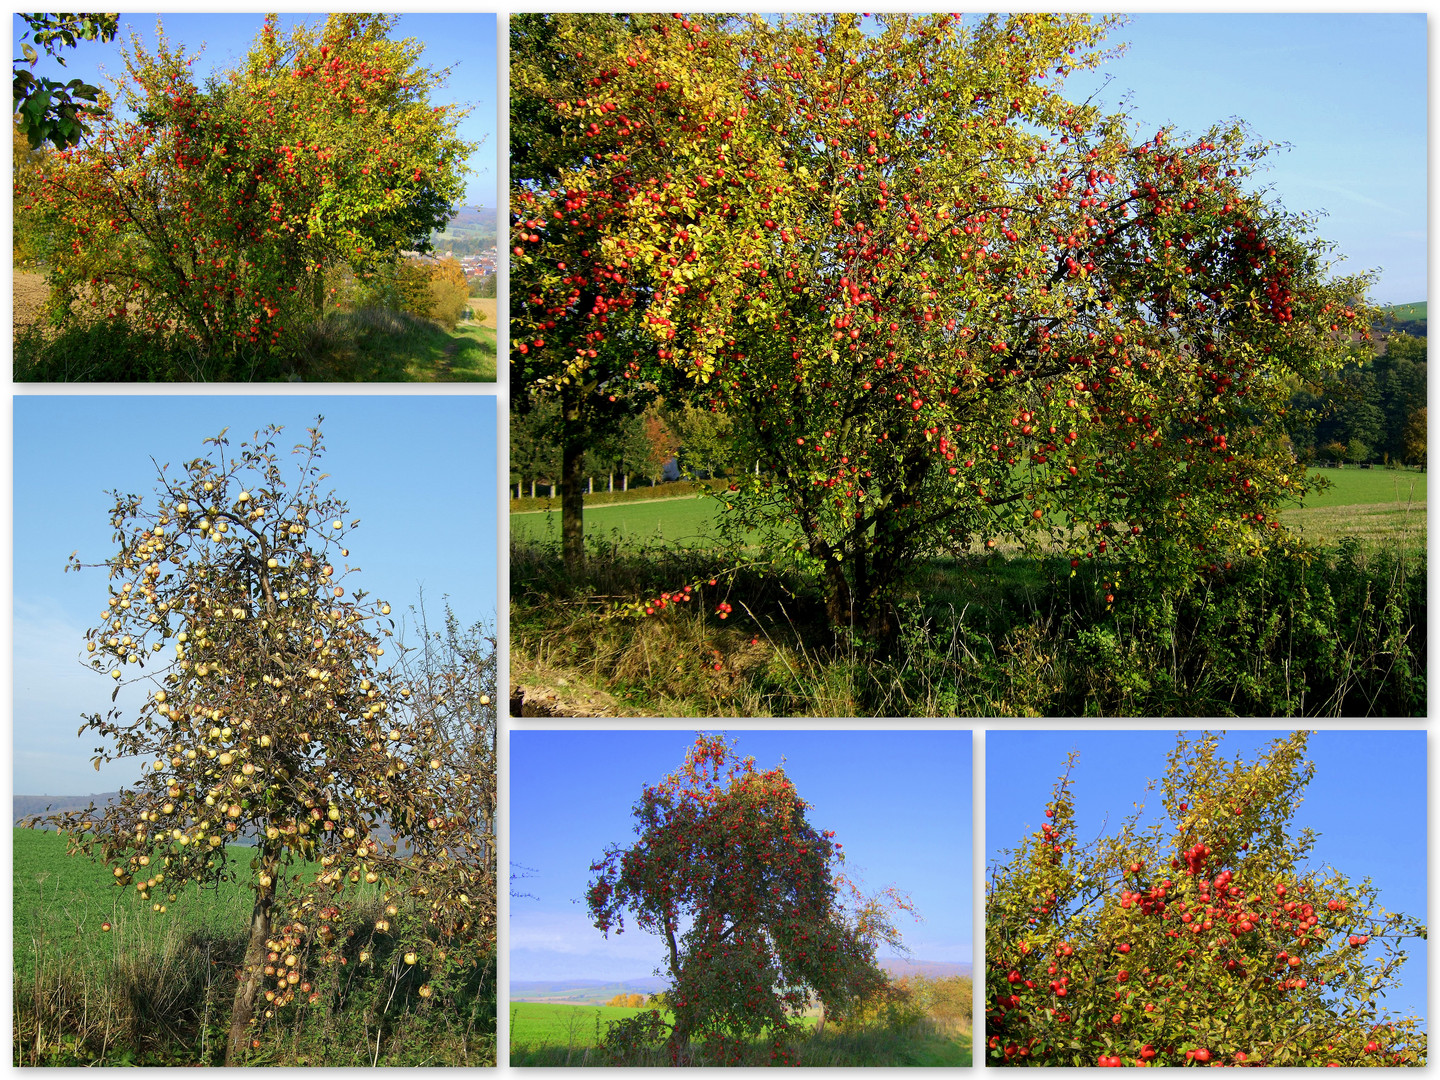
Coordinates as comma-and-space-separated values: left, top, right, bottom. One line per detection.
13, 395, 497, 795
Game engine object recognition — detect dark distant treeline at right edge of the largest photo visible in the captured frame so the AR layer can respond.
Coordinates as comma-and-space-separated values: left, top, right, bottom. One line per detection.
1286, 334, 1427, 465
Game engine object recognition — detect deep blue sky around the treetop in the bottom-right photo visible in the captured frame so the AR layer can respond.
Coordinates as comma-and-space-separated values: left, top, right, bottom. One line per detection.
985, 730, 1428, 1017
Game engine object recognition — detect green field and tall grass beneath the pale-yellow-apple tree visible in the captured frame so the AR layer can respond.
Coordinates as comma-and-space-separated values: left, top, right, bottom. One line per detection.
12, 828, 495, 1066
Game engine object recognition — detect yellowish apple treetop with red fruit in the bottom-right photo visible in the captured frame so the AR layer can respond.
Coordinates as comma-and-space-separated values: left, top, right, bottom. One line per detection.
985, 732, 1426, 1066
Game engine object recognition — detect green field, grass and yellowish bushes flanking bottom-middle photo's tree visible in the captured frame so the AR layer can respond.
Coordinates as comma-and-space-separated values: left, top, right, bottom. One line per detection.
510, 979, 972, 1067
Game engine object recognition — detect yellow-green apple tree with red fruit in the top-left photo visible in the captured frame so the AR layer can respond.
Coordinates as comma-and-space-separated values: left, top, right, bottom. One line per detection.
19, 13, 474, 374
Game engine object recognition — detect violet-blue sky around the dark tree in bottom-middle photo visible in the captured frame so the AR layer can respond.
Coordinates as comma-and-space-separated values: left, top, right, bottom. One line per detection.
508, 729, 973, 982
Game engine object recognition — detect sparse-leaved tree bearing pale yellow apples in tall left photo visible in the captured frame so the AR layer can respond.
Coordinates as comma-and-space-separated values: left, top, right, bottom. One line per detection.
27, 425, 495, 1064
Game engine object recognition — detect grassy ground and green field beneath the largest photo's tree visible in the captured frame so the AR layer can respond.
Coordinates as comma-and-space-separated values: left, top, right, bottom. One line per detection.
511, 467, 1427, 716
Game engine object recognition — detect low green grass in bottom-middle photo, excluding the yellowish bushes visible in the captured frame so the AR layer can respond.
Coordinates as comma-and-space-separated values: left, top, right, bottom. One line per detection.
510, 1001, 972, 1067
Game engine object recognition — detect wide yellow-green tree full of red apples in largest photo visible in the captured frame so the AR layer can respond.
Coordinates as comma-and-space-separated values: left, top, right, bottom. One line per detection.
511, 13, 1369, 639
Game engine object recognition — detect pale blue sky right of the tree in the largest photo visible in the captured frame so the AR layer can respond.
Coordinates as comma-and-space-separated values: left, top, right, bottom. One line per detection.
1066, 13, 1428, 304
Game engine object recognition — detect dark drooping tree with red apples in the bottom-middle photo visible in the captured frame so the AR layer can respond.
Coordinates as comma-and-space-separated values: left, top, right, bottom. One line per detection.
586, 736, 909, 1061
